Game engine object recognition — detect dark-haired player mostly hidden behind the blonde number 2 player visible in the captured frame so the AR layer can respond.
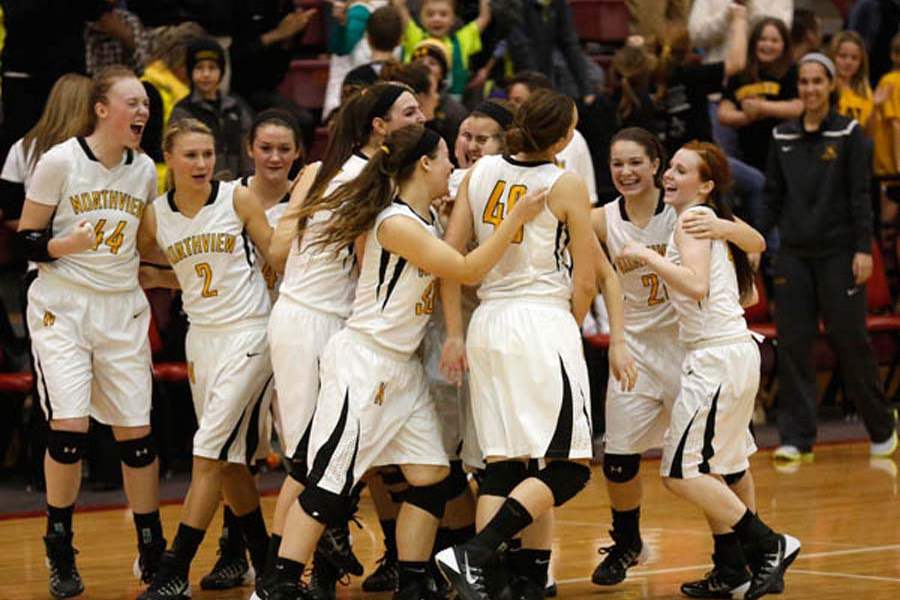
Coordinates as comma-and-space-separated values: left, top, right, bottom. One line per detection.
200, 109, 303, 590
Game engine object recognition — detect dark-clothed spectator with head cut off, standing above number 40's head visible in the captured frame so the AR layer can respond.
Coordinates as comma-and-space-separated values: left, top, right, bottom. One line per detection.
507, 0, 597, 105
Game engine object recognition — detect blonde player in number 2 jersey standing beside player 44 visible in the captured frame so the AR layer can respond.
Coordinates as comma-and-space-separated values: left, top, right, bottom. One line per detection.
139, 119, 272, 600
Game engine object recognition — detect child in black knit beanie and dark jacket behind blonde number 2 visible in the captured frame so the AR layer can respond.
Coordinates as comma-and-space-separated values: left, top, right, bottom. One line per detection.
170, 38, 253, 180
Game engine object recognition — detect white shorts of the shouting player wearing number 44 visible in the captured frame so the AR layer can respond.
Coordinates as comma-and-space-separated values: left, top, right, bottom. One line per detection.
26, 272, 153, 427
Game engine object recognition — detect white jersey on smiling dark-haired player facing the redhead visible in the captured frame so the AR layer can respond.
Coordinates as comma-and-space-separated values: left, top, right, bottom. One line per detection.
603, 196, 678, 333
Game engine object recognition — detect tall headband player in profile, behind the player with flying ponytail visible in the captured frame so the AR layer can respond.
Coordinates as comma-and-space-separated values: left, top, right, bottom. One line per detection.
269, 83, 425, 594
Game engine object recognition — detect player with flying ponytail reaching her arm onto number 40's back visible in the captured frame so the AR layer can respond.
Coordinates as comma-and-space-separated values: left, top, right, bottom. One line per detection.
255, 125, 543, 600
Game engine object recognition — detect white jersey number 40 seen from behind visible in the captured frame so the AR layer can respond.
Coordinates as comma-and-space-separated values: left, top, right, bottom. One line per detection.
468, 155, 572, 301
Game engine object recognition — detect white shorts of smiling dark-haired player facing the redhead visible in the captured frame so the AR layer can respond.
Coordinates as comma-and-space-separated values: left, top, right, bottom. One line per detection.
604, 325, 684, 454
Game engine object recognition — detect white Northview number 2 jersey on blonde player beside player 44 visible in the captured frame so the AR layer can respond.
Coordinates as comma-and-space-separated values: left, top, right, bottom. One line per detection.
153, 181, 271, 326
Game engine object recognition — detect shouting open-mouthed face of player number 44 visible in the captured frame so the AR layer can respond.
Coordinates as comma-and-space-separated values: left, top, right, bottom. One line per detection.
94, 77, 150, 149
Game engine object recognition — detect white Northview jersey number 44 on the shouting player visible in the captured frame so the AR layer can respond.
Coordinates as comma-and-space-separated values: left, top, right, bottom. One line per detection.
28, 137, 156, 292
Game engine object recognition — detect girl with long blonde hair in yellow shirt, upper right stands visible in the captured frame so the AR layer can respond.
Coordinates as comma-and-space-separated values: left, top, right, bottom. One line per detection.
829, 31, 872, 132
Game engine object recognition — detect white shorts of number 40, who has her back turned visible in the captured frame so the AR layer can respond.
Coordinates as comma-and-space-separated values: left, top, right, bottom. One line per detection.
466, 299, 592, 459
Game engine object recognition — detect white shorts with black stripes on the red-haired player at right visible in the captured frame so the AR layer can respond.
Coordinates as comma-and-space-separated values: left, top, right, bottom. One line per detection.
660, 335, 759, 479
